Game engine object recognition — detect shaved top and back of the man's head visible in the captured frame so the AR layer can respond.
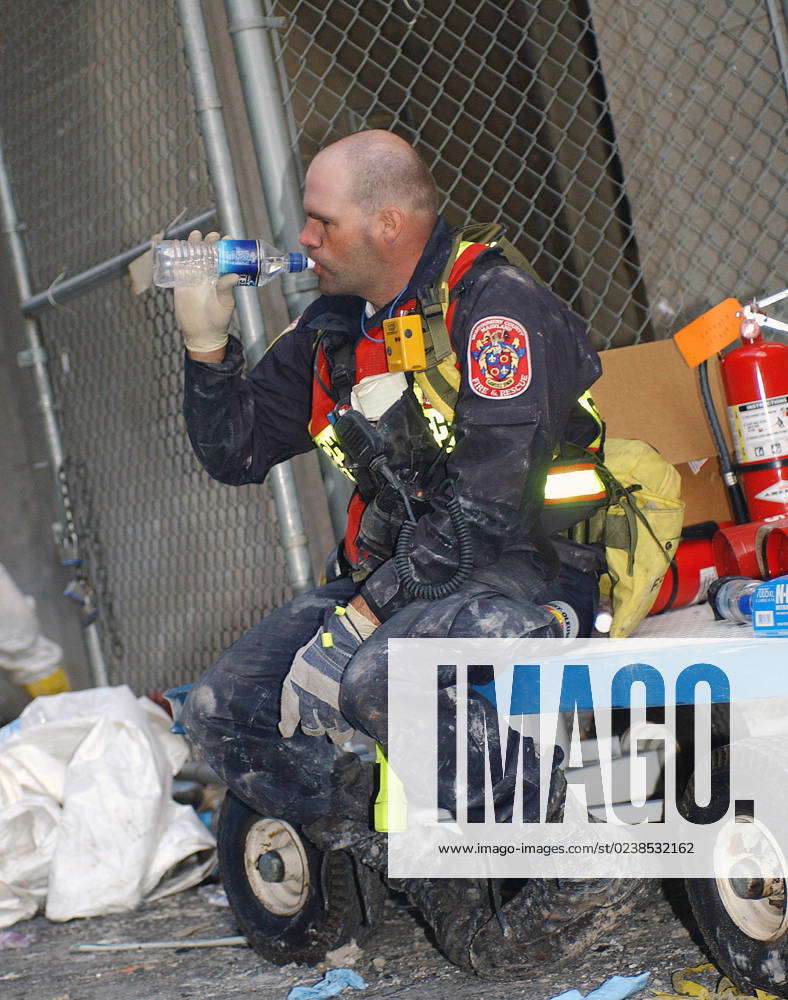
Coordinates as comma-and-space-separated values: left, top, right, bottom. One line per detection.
315, 129, 438, 223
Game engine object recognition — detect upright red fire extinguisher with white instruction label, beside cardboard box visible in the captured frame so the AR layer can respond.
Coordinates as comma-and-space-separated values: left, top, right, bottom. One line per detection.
721, 293, 788, 521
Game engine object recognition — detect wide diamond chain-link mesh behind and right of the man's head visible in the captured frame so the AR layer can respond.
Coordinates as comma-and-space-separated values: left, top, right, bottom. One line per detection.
268, 0, 786, 348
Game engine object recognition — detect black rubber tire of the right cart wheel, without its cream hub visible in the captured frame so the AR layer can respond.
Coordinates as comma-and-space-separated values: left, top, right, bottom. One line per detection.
681, 746, 788, 997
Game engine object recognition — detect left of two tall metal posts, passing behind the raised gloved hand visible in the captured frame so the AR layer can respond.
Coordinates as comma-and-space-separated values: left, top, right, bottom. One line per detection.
178, 0, 314, 593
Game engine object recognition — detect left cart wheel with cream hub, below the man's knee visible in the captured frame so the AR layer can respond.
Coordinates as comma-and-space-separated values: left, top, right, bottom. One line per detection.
217, 793, 372, 965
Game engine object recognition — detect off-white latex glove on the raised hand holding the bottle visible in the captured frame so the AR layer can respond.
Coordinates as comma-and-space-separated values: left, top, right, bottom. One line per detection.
175, 229, 238, 354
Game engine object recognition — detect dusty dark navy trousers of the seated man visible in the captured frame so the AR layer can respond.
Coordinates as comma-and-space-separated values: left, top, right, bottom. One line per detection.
182, 579, 584, 825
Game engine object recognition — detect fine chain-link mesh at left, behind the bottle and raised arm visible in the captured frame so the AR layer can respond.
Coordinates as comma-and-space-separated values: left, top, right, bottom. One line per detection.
0, 0, 289, 692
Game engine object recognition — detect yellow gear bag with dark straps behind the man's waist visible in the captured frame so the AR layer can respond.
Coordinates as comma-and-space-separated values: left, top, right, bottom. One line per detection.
588, 438, 685, 638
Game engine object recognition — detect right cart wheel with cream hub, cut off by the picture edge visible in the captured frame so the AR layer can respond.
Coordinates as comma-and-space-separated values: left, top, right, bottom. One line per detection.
682, 747, 788, 997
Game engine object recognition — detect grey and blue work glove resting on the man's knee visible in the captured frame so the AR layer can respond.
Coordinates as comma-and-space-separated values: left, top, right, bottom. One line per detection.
279, 606, 363, 744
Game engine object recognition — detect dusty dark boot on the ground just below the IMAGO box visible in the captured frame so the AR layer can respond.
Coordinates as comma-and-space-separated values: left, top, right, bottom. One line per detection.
471, 879, 658, 980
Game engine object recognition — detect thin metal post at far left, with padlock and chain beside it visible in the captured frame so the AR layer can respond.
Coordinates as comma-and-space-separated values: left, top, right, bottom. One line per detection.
0, 139, 109, 687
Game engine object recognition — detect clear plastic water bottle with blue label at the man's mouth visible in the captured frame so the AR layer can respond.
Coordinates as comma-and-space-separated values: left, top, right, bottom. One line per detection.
153, 240, 314, 288
